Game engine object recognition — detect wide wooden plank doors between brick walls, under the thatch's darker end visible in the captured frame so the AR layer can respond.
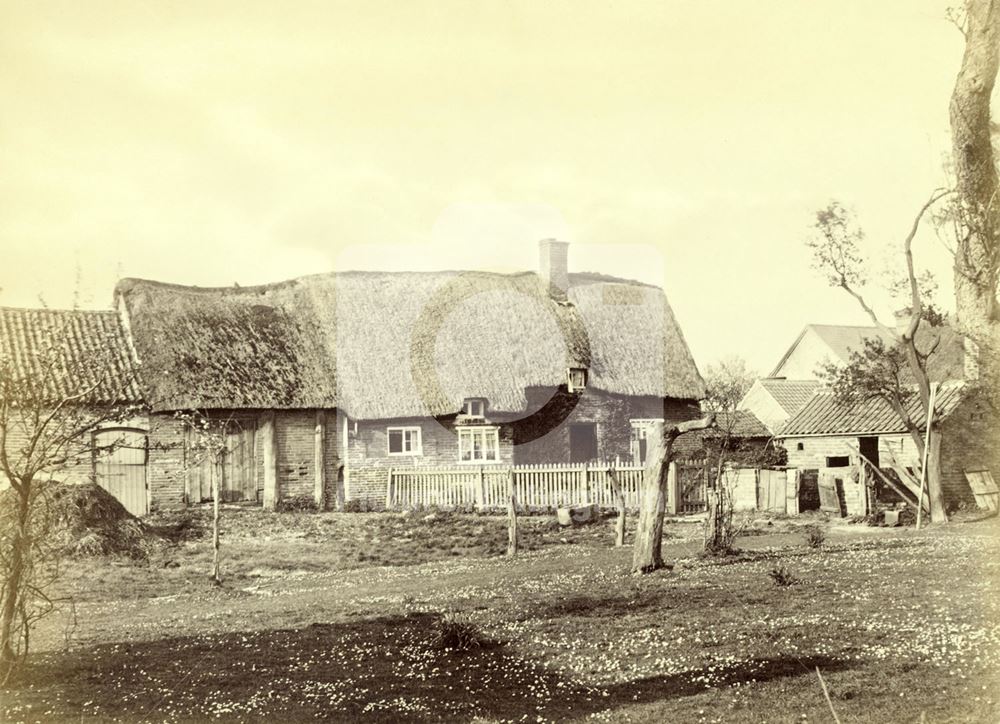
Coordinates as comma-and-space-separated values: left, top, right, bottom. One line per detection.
185, 425, 257, 503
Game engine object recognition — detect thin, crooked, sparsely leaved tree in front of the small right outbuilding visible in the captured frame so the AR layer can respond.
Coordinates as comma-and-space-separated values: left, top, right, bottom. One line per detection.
808, 201, 949, 522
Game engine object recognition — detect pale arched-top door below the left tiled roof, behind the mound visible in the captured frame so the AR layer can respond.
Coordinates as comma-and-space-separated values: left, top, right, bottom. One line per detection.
94, 429, 149, 516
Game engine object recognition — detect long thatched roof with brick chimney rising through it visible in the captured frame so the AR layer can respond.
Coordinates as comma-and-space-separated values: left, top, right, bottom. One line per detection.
116, 272, 704, 419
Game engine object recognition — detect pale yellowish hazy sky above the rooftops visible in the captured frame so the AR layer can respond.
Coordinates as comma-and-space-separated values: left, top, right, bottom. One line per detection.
0, 0, 962, 373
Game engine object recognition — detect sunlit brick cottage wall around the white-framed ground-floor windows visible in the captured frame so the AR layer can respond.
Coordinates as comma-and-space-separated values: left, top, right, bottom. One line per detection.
344, 417, 514, 507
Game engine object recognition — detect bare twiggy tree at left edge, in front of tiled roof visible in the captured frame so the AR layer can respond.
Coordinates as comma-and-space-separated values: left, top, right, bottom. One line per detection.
0, 316, 141, 682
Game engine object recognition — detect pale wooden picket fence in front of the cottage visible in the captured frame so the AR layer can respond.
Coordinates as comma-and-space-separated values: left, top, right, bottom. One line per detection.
385, 462, 706, 513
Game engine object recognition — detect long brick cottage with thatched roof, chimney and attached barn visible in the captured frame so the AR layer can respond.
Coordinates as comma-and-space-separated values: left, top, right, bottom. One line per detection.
3, 240, 704, 508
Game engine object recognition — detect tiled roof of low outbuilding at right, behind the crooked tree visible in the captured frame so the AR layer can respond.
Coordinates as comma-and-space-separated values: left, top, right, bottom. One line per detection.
777, 381, 965, 437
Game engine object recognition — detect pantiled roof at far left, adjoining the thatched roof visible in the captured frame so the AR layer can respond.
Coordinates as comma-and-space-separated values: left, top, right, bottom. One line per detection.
0, 307, 141, 403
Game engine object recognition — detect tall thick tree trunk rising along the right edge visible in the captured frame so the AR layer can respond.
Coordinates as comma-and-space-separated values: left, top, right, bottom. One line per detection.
950, 0, 1000, 405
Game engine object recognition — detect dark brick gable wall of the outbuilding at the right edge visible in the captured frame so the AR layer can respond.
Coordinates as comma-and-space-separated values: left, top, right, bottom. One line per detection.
941, 395, 1000, 507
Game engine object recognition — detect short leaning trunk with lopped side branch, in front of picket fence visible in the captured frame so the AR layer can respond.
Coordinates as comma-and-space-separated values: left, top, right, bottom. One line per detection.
632, 415, 715, 574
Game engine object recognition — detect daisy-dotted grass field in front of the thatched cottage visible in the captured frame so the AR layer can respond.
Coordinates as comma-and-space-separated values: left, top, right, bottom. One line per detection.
0, 511, 1000, 722
